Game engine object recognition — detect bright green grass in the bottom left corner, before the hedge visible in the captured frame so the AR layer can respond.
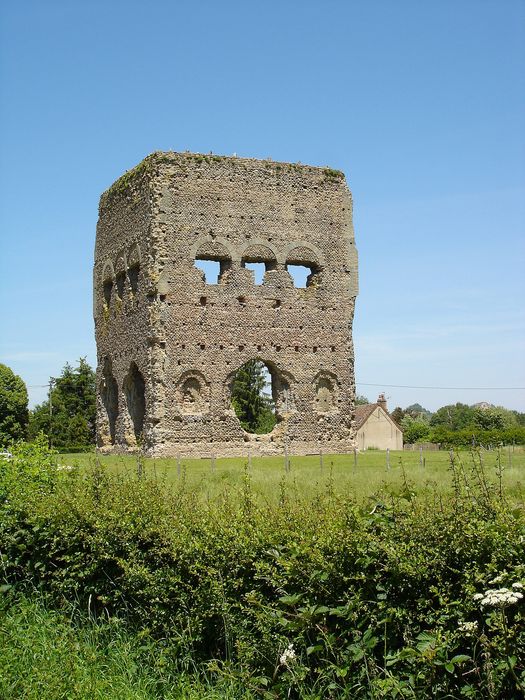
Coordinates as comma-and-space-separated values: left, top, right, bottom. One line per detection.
0, 595, 254, 700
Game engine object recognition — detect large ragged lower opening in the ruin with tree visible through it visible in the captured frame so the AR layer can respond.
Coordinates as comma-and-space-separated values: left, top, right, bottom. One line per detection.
230, 359, 278, 435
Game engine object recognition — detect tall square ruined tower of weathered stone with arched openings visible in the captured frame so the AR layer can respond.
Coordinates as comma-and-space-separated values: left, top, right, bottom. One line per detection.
94, 153, 357, 457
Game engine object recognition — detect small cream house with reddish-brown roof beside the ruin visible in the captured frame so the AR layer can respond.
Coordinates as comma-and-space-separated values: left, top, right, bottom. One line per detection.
354, 394, 403, 450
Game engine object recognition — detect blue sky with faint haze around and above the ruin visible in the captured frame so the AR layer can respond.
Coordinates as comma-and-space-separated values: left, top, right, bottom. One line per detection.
0, 0, 525, 411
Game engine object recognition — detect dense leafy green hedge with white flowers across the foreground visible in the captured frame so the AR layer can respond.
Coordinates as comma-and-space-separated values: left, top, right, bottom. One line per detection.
0, 442, 525, 698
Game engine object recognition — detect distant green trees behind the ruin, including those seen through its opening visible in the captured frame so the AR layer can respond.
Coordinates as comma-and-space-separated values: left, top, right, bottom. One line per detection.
4, 358, 525, 452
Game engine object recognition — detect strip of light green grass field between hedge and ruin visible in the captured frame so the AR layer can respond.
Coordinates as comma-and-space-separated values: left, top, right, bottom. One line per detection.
58, 447, 525, 501
